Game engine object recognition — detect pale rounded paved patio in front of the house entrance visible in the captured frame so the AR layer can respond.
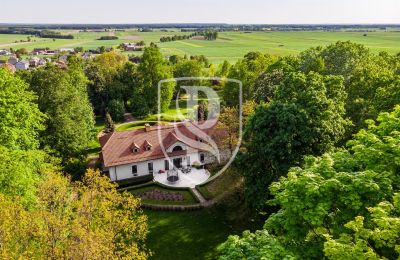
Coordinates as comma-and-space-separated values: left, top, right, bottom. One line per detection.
154, 168, 210, 188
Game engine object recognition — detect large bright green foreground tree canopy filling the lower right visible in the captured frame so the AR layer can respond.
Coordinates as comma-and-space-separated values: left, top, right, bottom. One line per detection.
221, 106, 400, 259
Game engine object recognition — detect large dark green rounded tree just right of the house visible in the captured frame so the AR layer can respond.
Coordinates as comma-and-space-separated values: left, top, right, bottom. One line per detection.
238, 73, 348, 209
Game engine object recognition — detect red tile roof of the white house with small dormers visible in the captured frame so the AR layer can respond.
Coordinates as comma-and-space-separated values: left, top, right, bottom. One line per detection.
100, 123, 217, 167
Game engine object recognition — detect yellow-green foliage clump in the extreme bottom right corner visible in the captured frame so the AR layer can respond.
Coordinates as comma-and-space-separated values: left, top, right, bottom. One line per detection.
324, 194, 400, 259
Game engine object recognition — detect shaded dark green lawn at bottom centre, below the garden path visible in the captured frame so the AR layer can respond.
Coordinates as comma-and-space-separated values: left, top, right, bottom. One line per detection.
144, 210, 234, 260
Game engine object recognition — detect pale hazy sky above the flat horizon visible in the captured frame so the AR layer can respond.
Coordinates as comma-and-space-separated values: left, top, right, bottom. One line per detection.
0, 0, 400, 24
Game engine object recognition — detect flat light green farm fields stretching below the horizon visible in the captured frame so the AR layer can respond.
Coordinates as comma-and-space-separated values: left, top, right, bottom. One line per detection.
0, 29, 400, 63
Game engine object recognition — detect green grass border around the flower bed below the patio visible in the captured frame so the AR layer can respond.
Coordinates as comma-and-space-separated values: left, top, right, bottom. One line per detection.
128, 183, 198, 205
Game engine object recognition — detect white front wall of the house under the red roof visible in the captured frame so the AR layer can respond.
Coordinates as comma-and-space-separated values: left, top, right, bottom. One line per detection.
108, 152, 200, 181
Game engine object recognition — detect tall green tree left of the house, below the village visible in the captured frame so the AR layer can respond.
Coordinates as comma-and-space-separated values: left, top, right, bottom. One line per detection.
30, 65, 95, 162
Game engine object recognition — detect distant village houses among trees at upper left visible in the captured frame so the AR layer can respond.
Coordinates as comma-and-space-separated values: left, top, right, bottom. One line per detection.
0, 43, 144, 72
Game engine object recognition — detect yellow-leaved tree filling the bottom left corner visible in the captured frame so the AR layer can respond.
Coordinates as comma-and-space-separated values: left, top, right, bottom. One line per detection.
0, 170, 149, 259
